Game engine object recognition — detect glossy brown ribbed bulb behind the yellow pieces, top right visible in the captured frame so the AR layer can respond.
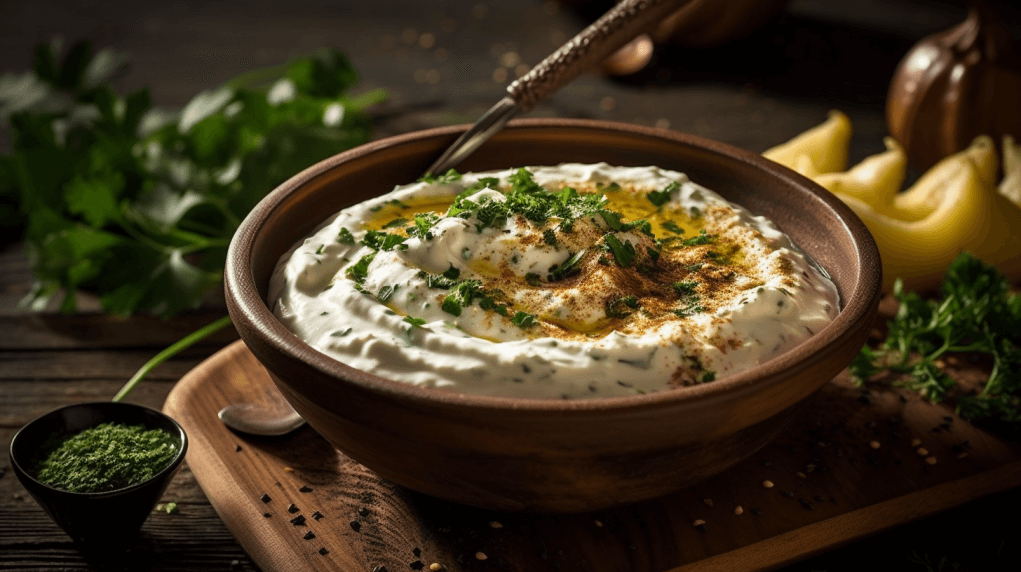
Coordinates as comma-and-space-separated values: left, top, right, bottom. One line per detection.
886, 0, 1021, 169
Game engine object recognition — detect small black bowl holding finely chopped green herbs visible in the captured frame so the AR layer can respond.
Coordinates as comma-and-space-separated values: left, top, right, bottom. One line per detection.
10, 401, 188, 547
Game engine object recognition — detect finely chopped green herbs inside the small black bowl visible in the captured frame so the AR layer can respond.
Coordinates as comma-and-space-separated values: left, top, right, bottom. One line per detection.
36, 423, 180, 492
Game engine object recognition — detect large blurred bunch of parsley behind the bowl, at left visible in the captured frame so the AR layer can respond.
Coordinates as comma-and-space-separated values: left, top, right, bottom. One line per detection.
0, 42, 385, 317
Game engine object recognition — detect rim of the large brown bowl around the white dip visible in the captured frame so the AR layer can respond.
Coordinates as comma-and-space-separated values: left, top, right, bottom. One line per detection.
224, 117, 882, 415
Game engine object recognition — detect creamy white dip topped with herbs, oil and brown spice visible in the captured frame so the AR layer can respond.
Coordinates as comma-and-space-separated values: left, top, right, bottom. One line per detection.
269, 163, 838, 398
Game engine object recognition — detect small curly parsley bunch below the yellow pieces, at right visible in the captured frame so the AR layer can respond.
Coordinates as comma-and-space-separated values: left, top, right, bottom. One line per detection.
850, 252, 1021, 422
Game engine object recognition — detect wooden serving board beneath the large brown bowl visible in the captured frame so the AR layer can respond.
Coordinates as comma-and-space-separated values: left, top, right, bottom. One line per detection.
164, 341, 1021, 572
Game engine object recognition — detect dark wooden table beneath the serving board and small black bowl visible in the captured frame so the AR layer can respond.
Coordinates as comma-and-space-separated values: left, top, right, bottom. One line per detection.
0, 0, 1021, 571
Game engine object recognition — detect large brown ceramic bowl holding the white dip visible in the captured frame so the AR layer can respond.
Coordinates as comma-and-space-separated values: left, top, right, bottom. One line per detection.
225, 120, 880, 513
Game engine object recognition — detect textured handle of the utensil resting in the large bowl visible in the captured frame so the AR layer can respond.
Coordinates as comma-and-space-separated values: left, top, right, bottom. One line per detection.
507, 0, 690, 111
